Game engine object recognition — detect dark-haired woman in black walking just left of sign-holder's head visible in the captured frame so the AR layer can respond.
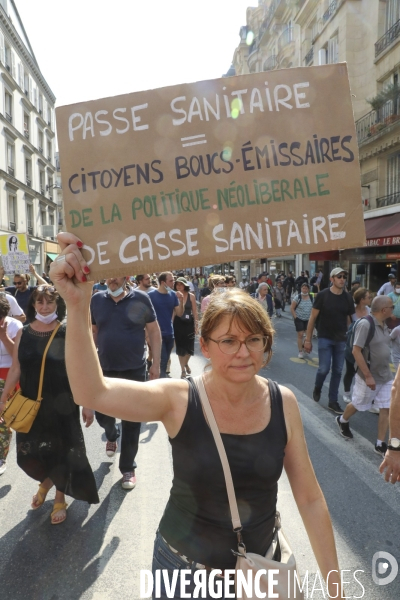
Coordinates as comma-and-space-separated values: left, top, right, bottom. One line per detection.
174, 277, 198, 379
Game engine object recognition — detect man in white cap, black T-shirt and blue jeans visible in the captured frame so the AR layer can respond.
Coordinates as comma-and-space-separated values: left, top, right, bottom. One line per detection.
304, 267, 355, 415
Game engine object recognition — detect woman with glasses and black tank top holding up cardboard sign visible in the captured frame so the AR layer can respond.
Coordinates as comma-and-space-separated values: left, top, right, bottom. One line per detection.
51, 233, 345, 598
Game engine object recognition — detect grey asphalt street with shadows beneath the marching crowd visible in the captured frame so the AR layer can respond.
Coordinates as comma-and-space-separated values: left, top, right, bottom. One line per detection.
0, 309, 400, 600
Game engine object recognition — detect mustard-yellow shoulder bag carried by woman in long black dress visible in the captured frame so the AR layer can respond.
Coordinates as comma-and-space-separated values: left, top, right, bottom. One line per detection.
1, 323, 61, 433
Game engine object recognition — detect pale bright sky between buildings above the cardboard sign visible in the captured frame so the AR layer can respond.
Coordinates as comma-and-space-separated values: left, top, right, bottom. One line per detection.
15, 0, 257, 106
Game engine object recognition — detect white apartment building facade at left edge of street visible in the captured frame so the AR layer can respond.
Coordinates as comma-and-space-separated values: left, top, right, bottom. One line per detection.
0, 0, 58, 282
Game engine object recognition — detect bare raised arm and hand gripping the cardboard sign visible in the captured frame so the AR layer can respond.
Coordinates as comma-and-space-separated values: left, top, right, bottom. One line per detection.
50, 233, 188, 436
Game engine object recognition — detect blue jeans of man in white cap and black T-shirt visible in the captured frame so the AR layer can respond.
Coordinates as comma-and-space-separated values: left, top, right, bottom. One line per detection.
315, 338, 346, 403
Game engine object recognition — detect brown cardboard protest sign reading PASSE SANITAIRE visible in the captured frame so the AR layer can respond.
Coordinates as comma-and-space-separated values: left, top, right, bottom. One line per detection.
57, 64, 365, 277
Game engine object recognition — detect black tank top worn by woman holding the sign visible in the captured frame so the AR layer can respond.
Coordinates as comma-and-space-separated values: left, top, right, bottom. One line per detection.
160, 378, 287, 569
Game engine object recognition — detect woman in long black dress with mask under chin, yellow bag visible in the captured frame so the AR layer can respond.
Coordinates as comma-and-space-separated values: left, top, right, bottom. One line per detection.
0, 285, 99, 525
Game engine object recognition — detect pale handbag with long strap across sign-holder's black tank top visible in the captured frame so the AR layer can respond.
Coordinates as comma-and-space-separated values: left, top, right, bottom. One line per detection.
193, 375, 304, 600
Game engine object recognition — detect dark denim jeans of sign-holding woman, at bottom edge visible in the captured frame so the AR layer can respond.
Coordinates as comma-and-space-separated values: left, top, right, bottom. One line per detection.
152, 532, 235, 600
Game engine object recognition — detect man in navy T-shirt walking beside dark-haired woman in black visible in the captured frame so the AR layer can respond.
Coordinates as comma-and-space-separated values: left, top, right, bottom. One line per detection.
148, 271, 185, 378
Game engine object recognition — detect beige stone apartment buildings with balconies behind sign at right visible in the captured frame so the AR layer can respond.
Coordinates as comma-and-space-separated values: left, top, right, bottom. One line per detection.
229, 0, 400, 290
